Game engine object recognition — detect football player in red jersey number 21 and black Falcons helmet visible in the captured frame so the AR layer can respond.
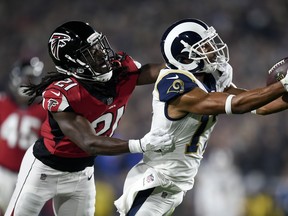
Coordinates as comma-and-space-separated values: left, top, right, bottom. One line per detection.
5, 21, 172, 216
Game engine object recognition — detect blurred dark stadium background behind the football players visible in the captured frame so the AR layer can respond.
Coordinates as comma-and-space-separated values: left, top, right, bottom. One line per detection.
0, 0, 288, 216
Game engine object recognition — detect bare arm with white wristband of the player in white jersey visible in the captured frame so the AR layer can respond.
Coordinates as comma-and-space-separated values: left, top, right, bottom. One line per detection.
168, 78, 286, 117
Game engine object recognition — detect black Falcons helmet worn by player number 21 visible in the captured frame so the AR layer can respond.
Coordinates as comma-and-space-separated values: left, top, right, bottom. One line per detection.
48, 21, 115, 82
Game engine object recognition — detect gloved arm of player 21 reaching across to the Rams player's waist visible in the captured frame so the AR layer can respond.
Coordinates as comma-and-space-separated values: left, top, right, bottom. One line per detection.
52, 112, 173, 155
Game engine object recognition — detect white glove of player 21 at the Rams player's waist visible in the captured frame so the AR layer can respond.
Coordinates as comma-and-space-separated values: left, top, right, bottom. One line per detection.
128, 129, 174, 153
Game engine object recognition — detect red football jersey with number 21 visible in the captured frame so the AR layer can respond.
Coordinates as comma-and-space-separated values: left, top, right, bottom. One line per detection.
41, 53, 139, 158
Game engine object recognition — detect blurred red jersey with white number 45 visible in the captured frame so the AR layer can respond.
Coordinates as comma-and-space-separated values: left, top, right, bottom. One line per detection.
0, 93, 46, 172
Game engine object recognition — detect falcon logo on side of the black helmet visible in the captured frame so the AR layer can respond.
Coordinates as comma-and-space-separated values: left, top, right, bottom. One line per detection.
49, 33, 71, 61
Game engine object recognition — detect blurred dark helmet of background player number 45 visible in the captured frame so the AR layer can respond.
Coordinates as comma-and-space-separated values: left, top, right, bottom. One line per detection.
9, 57, 44, 98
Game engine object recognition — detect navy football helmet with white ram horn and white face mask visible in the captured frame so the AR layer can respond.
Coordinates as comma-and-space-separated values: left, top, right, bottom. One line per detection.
160, 18, 229, 73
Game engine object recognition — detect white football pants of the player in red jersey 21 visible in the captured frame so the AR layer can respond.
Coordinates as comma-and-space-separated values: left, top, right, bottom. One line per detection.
5, 145, 96, 216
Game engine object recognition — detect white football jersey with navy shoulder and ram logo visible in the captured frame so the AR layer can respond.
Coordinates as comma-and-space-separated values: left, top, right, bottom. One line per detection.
143, 66, 232, 191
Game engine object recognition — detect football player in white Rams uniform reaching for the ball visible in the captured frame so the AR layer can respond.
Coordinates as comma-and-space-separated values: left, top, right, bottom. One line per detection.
115, 18, 288, 216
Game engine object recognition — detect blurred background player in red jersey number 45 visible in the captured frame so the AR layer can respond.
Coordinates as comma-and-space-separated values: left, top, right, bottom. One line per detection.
0, 57, 46, 215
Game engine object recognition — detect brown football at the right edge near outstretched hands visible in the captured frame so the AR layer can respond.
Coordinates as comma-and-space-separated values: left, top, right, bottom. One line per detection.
266, 57, 288, 85
